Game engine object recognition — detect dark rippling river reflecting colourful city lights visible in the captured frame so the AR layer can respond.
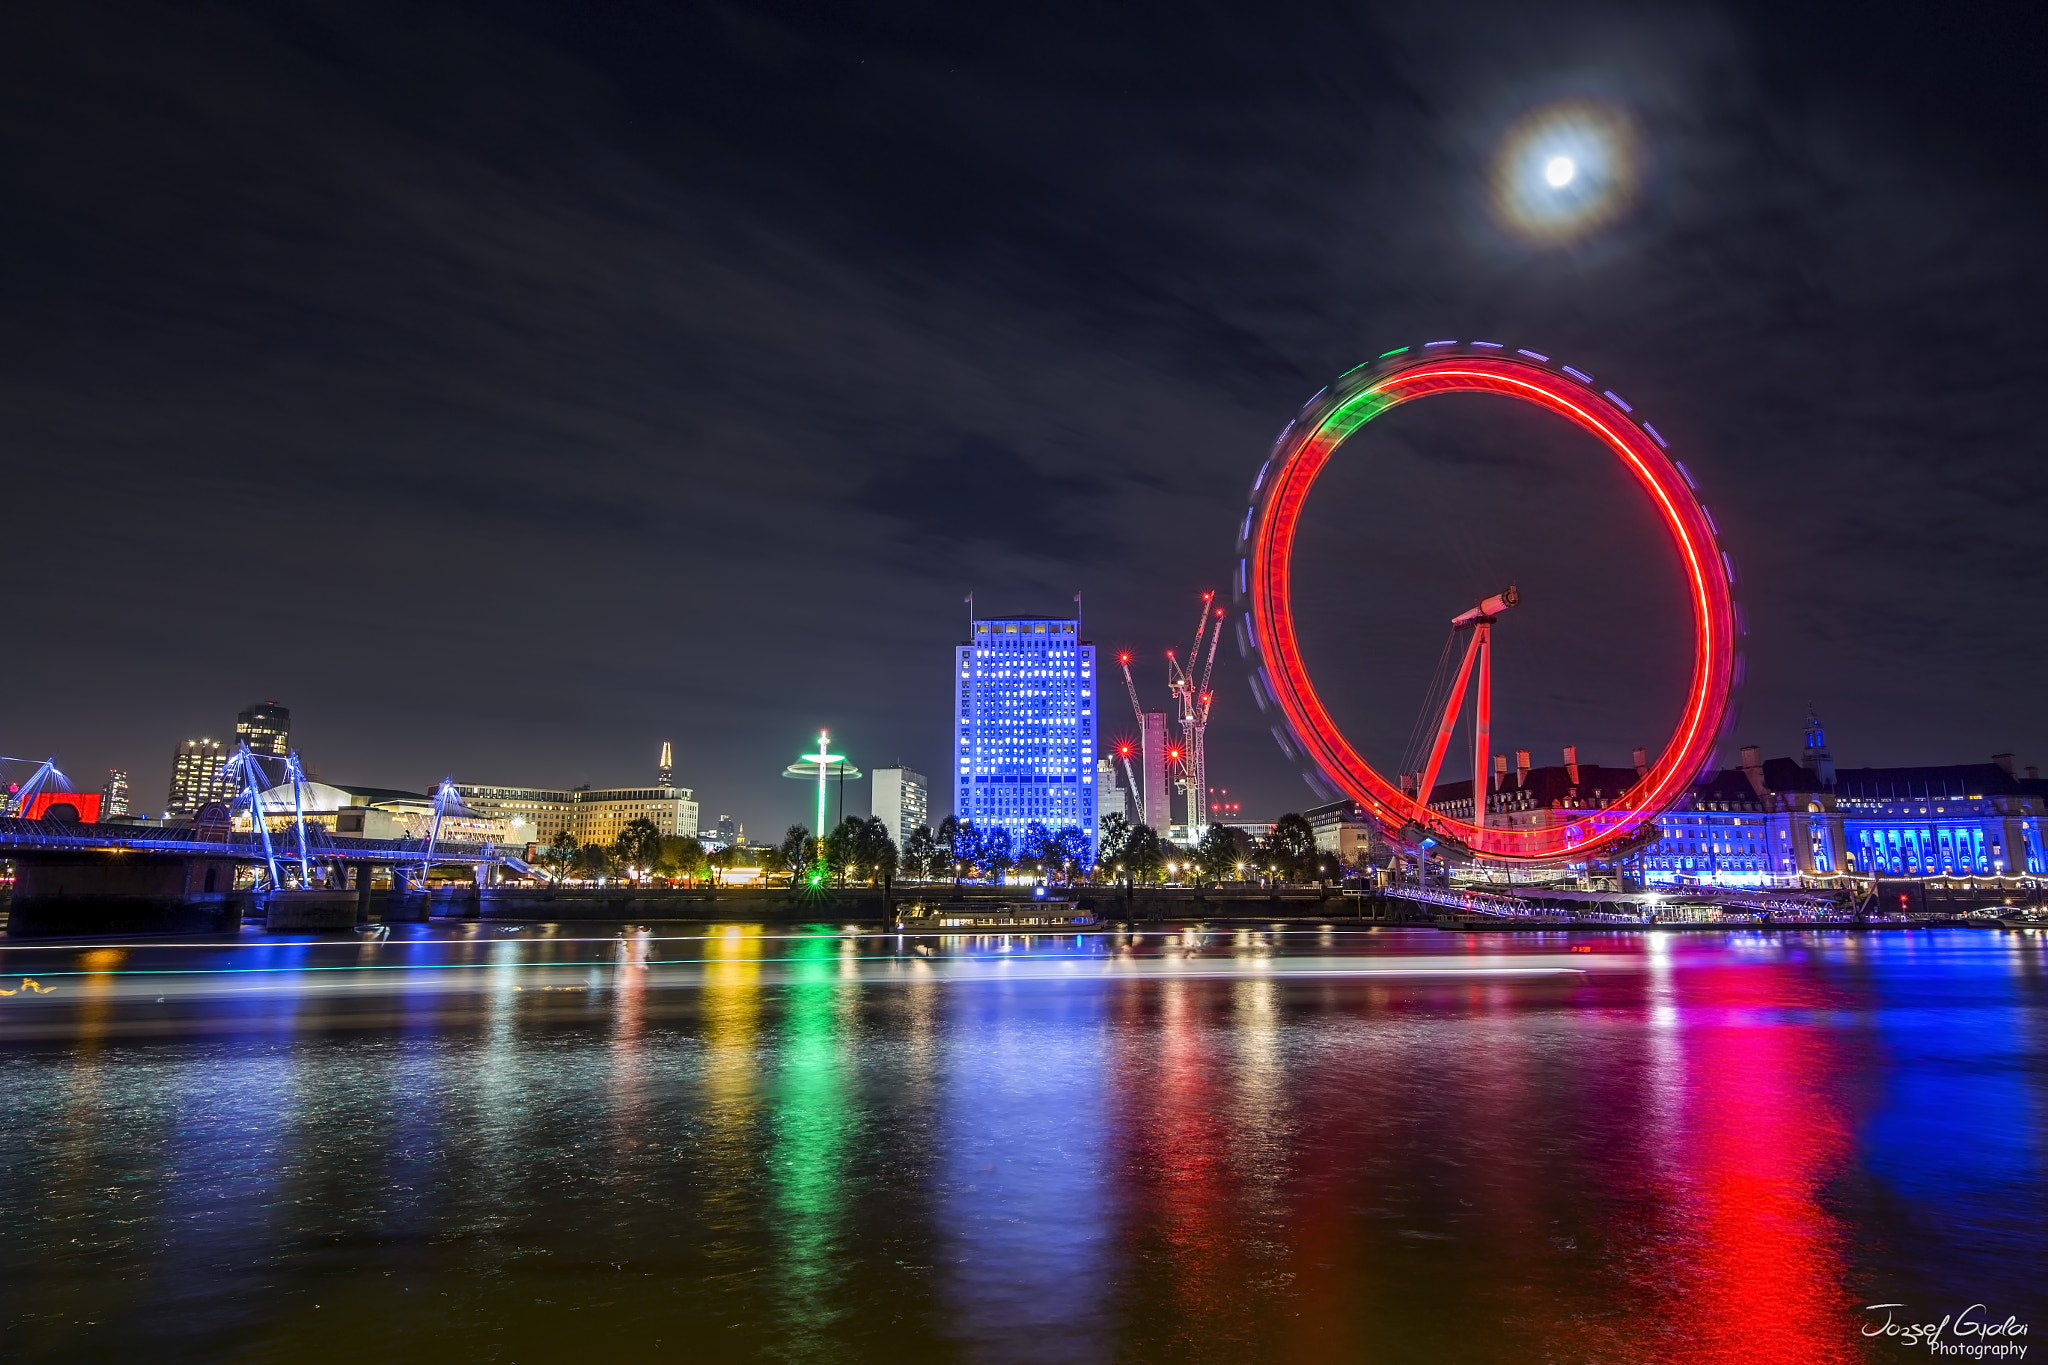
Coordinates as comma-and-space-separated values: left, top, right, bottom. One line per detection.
0, 925, 2048, 1365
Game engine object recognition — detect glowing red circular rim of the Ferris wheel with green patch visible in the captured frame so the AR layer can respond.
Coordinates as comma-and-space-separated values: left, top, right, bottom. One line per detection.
1237, 351, 1741, 864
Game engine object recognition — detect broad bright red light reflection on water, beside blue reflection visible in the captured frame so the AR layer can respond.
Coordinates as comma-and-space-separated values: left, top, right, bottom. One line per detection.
1645, 962, 1862, 1365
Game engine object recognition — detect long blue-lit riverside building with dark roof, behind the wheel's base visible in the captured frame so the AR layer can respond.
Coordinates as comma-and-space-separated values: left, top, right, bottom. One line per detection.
1430, 716, 2048, 890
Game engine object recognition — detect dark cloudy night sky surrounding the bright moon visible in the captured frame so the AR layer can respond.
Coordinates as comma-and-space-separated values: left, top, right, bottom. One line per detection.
0, 2, 2048, 837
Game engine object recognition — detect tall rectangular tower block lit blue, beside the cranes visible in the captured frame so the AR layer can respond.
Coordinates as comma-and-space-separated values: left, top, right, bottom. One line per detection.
952, 616, 1096, 857
